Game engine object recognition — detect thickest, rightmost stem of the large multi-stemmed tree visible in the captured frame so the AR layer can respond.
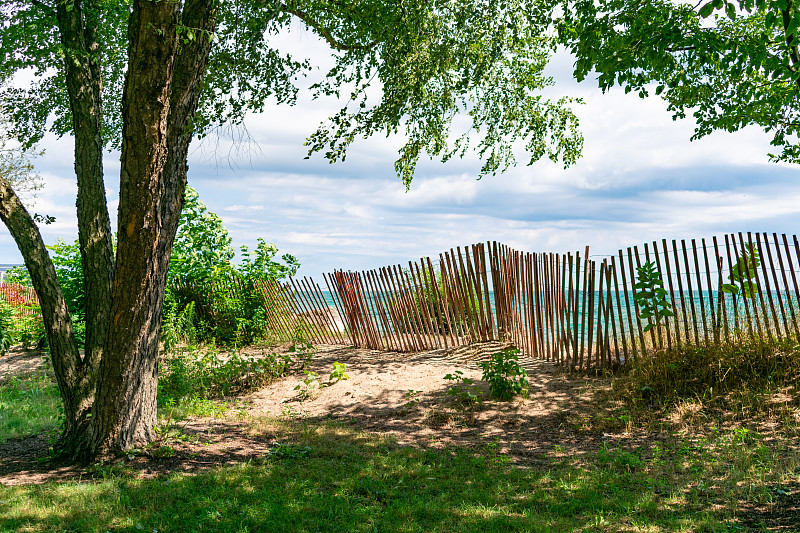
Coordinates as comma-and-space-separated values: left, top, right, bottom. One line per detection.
76, 0, 214, 459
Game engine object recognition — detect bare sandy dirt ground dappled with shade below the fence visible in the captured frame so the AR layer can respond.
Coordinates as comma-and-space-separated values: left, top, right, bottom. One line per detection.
0, 343, 612, 485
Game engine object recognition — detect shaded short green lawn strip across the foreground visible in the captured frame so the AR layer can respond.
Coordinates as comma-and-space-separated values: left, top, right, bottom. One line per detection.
0, 420, 797, 532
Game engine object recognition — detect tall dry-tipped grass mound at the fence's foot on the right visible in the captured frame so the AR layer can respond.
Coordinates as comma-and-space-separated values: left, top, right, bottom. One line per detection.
596, 340, 800, 437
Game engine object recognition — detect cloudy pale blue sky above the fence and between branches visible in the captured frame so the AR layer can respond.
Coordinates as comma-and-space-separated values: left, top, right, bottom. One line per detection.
0, 23, 800, 281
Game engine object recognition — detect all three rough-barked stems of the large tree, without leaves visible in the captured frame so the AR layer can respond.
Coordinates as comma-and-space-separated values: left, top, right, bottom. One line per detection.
0, 0, 218, 461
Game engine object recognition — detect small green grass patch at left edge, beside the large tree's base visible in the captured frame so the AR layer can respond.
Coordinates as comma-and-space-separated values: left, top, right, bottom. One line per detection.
0, 373, 61, 442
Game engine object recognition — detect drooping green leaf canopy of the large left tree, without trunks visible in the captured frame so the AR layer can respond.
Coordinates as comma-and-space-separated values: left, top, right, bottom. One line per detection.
0, 0, 583, 185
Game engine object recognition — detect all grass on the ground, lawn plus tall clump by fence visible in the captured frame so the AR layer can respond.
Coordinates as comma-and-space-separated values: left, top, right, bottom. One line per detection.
0, 343, 800, 533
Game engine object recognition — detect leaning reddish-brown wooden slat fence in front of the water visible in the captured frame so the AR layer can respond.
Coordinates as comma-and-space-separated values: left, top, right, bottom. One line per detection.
260, 233, 800, 369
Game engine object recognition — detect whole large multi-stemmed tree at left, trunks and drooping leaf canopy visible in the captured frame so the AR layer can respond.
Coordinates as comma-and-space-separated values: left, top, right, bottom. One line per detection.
0, 0, 582, 460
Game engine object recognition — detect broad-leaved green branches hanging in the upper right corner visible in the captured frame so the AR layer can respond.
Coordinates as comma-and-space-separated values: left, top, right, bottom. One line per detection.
558, 0, 800, 163
